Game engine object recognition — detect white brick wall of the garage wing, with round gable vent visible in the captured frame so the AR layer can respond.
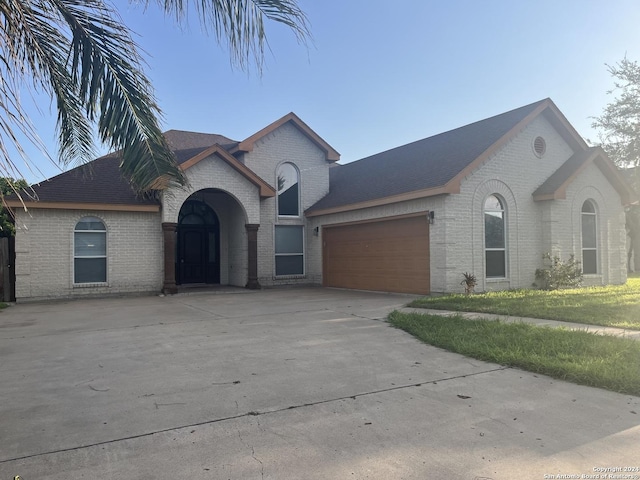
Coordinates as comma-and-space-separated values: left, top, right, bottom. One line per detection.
308, 116, 626, 293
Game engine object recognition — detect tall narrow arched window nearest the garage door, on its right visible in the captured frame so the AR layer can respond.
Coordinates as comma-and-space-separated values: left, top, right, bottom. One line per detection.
484, 195, 507, 278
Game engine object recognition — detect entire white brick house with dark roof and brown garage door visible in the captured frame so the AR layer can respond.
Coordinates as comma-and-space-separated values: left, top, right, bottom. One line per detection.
8, 99, 634, 301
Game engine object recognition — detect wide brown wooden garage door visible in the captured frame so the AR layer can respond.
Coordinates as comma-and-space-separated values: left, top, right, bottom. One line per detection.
322, 215, 430, 294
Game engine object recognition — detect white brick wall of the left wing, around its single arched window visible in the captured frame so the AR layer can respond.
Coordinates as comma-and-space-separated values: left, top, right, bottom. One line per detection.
16, 208, 163, 301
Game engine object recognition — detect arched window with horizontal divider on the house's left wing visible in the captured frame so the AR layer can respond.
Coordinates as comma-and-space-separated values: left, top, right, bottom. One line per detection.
73, 217, 107, 284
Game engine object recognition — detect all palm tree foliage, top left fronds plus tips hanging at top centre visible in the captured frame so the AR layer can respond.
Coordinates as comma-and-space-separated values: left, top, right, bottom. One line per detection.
0, 0, 309, 192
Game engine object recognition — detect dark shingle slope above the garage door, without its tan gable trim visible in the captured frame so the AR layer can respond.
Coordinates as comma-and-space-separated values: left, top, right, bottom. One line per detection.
307, 100, 547, 212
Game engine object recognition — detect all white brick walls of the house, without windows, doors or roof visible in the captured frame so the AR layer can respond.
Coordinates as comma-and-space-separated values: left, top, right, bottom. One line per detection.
16, 108, 626, 300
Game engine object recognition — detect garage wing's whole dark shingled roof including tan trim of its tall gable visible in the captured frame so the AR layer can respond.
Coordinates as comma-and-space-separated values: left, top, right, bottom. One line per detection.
306, 99, 586, 216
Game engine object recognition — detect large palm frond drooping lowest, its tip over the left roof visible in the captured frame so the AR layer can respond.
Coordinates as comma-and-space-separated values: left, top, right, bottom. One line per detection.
50, 0, 186, 191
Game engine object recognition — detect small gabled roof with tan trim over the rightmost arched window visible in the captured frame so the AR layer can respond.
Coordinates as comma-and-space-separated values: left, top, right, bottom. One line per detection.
533, 147, 636, 205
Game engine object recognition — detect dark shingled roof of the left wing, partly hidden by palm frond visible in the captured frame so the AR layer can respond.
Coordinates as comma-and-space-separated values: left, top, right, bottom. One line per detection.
14, 130, 238, 205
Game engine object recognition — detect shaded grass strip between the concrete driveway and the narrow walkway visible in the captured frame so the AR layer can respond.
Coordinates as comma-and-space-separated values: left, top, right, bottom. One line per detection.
389, 311, 640, 396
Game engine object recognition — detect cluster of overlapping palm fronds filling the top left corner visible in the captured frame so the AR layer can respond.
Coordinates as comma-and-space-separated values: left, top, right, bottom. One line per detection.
0, 0, 185, 191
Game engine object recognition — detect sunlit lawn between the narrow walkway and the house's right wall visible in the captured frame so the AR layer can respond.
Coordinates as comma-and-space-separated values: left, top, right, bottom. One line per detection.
409, 276, 640, 330
